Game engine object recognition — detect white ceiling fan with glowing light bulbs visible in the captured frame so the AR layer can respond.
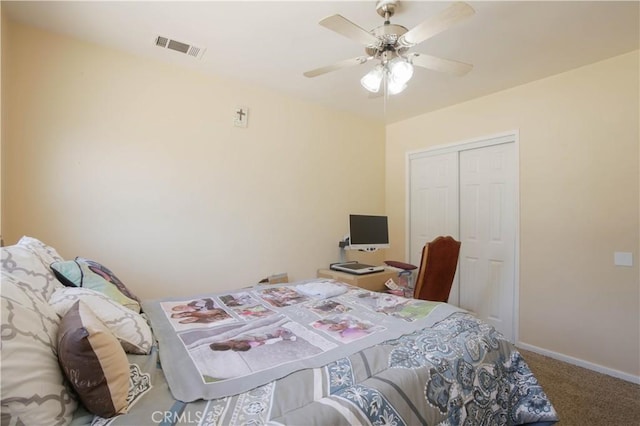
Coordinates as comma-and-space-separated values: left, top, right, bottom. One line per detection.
304, 0, 475, 95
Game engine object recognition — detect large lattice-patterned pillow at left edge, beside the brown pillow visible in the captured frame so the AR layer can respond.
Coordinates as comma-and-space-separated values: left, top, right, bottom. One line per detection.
0, 271, 77, 425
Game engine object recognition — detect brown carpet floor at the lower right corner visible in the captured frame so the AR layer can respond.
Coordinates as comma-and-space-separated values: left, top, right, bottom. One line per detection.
518, 348, 640, 426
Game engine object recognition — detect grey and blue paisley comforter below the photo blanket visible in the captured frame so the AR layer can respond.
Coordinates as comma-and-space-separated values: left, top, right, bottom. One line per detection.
72, 312, 558, 426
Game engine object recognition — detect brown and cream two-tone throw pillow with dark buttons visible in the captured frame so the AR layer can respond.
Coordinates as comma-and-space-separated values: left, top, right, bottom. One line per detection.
58, 301, 129, 418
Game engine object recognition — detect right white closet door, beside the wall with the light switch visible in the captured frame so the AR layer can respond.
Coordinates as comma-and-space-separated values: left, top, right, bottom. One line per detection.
458, 143, 517, 341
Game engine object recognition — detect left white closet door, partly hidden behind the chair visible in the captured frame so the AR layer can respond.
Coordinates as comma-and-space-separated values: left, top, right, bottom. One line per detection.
408, 152, 459, 305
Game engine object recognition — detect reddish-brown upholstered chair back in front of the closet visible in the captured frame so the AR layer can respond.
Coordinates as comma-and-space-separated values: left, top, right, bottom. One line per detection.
413, 236, 461, 302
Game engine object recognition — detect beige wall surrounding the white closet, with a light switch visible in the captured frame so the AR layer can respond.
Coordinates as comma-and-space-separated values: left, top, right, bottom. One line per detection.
386, 52, 640, 380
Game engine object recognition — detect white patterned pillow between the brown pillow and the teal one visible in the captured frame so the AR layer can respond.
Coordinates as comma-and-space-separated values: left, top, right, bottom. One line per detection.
49, 287, 153, 355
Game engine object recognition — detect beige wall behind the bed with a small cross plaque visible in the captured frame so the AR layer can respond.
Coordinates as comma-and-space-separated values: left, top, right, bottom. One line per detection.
3, 22, 385, 298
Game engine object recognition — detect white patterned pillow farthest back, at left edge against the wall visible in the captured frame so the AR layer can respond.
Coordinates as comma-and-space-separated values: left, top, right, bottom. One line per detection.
1, 237, 63, 302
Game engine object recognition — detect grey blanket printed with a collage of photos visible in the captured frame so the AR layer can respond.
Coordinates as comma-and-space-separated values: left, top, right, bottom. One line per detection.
143, 280, 457, 402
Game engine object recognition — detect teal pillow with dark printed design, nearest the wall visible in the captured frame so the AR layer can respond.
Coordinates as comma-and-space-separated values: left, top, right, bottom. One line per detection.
51, 259, 140, 312
